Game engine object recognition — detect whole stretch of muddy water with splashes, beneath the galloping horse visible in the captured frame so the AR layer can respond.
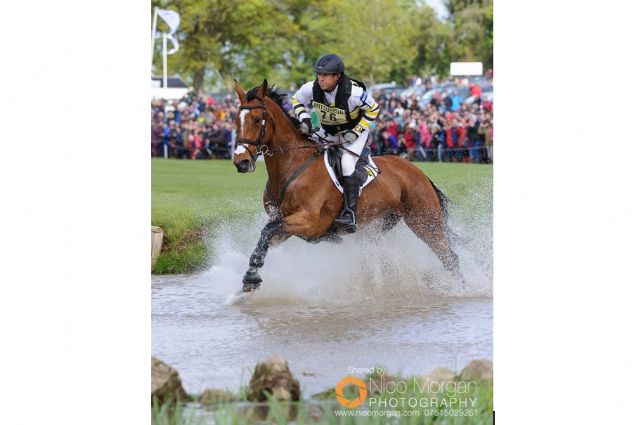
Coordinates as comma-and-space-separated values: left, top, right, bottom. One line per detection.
152, 218, 493, 396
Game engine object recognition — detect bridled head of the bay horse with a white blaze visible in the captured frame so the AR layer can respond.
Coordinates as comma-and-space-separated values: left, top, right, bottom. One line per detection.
233, 79, 273, 173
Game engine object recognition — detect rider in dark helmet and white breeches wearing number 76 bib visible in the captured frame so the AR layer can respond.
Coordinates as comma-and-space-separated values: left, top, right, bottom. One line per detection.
292, 54, 380, 233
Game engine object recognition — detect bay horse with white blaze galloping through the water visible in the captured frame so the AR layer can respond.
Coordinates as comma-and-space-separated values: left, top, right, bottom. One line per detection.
233, 79, 464, 292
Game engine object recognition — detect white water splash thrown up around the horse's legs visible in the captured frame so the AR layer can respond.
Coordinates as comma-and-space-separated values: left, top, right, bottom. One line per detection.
207, 192, 493, 305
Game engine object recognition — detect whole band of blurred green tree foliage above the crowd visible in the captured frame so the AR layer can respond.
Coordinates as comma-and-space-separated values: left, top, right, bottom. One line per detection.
151, 0, 493, 91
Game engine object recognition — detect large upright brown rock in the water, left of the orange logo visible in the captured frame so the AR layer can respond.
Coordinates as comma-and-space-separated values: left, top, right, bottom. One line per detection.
247, 356, 300, 401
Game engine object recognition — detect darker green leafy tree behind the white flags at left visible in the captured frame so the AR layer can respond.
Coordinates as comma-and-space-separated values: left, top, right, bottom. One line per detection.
152, 0, 297, 92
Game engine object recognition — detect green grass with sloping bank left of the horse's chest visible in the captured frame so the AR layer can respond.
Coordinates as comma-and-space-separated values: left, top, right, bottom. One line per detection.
151, 159, 266, 273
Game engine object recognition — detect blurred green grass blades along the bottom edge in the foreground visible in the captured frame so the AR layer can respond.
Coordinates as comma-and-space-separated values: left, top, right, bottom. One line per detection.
152, 378, 493, 425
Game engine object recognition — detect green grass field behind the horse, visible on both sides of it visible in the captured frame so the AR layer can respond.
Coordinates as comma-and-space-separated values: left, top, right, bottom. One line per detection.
151, 159, 493, 274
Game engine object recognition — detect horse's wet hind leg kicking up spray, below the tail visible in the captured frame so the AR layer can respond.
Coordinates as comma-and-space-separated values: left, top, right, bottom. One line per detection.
404, 213, 464, 282
